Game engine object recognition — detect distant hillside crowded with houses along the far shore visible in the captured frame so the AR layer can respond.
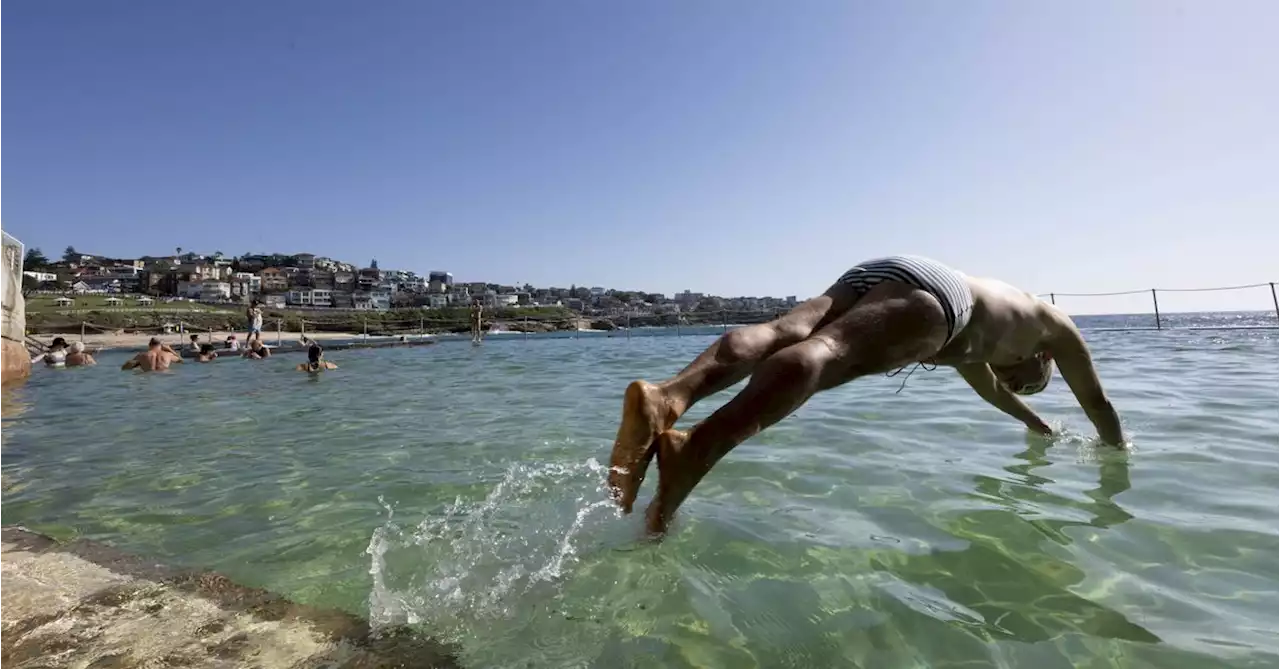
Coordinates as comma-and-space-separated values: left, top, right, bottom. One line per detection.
23, 247, 796, 321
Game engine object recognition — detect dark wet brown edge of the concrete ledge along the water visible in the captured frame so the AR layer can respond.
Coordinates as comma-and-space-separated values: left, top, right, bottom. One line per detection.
0, 526, 462, 669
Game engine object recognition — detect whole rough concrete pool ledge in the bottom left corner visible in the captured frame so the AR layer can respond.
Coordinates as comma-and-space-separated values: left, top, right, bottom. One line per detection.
0, 526, 460, 669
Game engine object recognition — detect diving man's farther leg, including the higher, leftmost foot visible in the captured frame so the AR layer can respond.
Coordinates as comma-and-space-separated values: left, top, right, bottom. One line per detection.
609, 284, 858, 513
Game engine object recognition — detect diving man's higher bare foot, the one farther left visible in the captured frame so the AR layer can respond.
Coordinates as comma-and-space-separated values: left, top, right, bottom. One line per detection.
609, 381, 677, 513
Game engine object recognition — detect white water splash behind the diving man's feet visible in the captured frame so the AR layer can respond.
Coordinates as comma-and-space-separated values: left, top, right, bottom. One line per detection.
366, 458, 618, 641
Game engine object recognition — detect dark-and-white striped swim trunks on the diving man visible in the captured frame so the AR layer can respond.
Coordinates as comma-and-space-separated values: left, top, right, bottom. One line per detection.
837, 256, 973, 343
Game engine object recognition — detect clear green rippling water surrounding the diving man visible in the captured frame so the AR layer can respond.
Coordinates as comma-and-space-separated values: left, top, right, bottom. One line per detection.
0, 321, 1280, 669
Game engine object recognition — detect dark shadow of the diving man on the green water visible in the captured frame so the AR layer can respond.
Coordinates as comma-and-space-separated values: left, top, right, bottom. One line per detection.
872, 437, 1161, 643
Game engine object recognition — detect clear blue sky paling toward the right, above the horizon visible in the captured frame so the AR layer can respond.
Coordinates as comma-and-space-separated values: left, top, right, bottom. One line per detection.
0, 0, 1280, 312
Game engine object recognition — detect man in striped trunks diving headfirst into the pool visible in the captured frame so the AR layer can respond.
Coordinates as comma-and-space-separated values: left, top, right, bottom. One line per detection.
609, 256, 1124, 535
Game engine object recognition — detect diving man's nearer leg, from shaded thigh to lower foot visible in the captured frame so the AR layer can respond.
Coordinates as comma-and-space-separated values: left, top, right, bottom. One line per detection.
646, 283, 947, 533
